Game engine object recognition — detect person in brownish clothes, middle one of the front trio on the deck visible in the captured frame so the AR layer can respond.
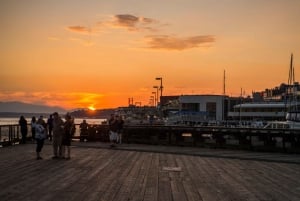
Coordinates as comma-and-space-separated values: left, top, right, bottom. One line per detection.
52, 112, 64, 159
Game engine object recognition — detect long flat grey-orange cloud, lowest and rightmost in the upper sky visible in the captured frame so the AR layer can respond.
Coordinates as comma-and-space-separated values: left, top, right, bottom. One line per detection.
145, 35, 215, 50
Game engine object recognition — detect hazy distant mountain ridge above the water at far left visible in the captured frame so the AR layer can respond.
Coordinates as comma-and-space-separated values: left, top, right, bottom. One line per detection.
0, 102, 67, 114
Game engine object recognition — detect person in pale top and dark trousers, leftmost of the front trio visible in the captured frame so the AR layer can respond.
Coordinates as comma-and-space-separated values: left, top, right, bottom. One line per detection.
34, 118, 47, 160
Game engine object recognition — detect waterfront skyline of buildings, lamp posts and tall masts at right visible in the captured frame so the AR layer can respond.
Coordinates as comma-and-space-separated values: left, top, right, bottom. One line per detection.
122, 54, 300, 124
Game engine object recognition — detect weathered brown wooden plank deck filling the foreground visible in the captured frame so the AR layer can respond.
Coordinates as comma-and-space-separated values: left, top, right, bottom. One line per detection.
0, 142, 300, 201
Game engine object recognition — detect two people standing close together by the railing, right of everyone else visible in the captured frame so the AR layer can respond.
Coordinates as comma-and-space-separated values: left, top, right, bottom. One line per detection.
108, 114, 124, 147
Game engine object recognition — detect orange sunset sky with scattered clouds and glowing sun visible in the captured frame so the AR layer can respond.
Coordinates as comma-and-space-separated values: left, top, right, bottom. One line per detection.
0, 0, 300, 109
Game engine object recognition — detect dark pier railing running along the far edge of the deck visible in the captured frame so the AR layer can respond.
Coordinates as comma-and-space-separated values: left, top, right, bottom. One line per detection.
0, 125, 300, 153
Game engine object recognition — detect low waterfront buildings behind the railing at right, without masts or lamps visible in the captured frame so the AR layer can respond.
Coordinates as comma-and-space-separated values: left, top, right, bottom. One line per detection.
161, 82, 300, 122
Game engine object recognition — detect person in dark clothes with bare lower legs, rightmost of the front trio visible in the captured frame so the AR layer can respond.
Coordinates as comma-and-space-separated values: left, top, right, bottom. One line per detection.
62, 113, 74, 160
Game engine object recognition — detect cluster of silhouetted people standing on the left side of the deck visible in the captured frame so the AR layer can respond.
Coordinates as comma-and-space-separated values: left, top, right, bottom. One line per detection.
19, 112, 75, 160
